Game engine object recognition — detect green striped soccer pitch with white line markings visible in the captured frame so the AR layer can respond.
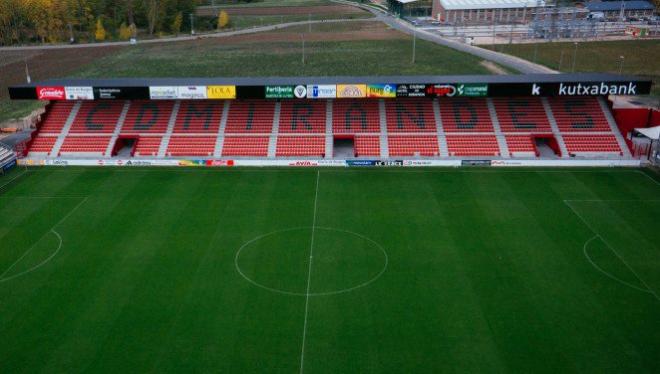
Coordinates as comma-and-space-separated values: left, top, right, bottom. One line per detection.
0, 167, 660, 373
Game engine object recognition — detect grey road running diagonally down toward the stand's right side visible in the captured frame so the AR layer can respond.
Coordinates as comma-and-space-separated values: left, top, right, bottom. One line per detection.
332, 0, 558, 74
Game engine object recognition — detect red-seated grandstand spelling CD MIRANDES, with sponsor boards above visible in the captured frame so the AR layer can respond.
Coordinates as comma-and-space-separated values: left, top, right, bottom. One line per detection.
10, 74, 648, 164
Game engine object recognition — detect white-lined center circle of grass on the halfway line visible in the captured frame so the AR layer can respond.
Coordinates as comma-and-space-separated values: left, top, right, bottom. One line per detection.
234, 227, 389, 296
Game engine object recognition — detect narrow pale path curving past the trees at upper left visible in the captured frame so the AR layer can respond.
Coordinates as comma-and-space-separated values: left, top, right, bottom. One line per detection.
0, 17, 380, 52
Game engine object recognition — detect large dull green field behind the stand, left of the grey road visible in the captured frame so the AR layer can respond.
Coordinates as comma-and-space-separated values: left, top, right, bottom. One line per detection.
73, 39, 488, 78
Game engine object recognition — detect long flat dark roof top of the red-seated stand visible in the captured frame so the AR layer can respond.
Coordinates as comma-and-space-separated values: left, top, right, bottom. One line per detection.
9, 73, 647, 87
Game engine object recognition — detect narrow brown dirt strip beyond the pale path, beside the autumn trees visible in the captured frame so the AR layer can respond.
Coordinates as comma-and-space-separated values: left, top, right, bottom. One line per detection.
196, 5, 364, 17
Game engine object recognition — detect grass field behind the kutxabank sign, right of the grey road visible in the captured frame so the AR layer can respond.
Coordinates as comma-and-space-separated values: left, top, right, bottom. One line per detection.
484, 39, 660, 96
